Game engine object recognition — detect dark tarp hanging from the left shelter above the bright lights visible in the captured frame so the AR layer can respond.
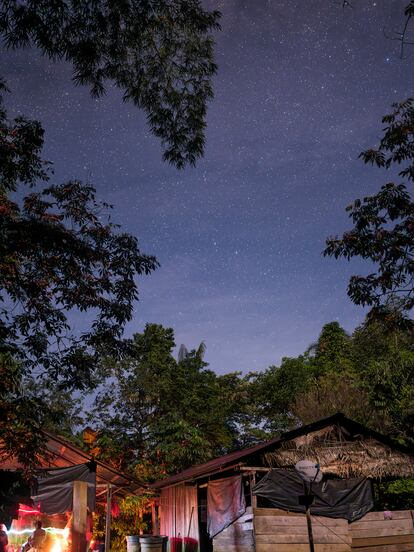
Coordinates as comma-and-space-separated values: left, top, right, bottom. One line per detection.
32, 462, 96, 515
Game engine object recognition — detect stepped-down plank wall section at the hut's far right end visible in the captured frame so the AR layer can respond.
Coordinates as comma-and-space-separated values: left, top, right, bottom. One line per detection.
349, 510, 414, 552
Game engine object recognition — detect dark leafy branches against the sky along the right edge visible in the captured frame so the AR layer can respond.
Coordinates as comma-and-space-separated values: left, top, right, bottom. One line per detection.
325, 99, 414, 324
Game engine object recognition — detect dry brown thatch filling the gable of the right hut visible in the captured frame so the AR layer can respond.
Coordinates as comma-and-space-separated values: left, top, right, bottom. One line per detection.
264, 424, 414, 479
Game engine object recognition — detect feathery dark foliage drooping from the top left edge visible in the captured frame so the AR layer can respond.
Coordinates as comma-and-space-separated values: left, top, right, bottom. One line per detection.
0, 0, 219, 168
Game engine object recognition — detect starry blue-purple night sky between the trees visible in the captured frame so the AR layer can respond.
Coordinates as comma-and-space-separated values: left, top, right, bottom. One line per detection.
0, 0, 414, 373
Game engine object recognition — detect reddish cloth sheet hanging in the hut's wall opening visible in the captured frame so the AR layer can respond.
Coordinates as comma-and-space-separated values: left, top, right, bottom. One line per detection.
207, 475, 246, 538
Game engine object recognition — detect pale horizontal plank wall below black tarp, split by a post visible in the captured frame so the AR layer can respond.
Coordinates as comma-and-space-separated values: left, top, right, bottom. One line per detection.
253, 508, 351, 552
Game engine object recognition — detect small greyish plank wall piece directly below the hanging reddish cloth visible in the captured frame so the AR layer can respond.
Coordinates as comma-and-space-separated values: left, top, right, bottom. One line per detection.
213, 507, 254, 552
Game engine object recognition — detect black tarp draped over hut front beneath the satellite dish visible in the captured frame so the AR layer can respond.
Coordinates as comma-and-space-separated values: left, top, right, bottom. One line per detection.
253, 469, 374, 521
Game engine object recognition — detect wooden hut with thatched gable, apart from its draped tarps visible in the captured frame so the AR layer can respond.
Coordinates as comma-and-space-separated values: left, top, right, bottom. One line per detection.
153, 413, 414, 552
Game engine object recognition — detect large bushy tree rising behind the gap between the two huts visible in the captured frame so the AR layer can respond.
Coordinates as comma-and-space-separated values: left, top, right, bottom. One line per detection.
93, 324, 244, 478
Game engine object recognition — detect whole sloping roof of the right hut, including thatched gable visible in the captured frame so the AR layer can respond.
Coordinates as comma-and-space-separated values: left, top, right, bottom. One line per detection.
151, 412, 414, 491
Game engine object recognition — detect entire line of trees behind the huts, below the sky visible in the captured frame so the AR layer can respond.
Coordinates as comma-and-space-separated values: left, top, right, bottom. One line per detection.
56, 321, 414, 480
